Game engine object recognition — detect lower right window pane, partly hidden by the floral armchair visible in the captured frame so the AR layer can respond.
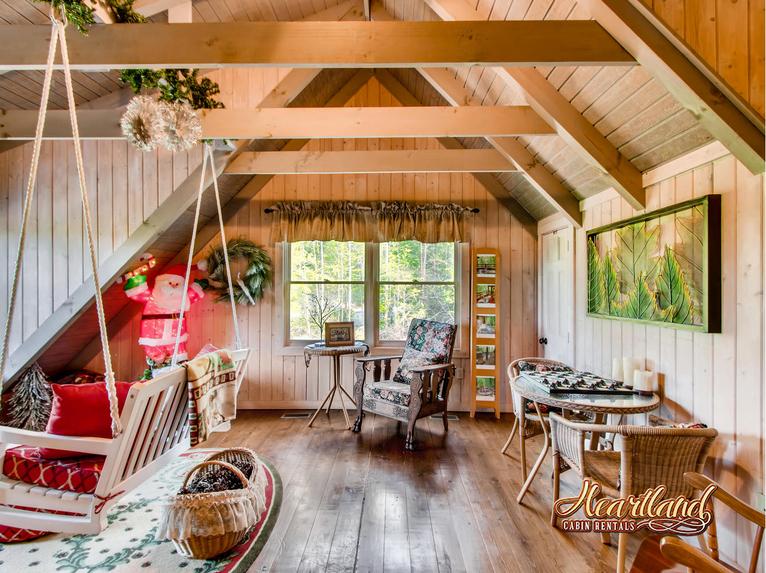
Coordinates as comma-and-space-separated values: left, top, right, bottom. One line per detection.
379, 285, 455, 341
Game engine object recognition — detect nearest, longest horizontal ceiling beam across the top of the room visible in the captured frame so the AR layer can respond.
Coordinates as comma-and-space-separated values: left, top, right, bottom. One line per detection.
0, 20, 633, 70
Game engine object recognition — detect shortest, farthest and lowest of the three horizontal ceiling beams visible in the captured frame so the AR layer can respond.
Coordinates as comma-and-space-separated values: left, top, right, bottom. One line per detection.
226, 149, 516, 175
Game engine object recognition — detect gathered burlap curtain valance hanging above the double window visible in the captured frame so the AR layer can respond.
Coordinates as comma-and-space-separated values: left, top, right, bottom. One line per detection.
267, 201, 472, 243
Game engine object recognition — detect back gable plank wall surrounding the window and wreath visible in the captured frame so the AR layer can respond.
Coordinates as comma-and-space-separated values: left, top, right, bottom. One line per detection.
82, 79, 537, 411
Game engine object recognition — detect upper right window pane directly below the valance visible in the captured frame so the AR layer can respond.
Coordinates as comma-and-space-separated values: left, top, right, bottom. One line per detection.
380, 241, 455, 282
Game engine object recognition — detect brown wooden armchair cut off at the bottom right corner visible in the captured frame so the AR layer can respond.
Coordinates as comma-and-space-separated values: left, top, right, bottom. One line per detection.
660, 472, 766, 573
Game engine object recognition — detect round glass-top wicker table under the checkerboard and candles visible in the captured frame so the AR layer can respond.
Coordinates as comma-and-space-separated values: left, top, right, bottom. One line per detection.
511, 372, 660, 503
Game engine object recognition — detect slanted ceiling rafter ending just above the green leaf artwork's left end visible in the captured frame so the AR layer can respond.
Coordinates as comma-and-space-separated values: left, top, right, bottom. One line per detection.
425, 0, 646, 209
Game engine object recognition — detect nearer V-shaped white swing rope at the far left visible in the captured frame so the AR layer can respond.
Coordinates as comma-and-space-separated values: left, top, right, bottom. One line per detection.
0, 13, 122, 437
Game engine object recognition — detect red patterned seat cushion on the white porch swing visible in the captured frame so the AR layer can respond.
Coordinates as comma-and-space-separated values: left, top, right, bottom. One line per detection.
3, 446, 104, 493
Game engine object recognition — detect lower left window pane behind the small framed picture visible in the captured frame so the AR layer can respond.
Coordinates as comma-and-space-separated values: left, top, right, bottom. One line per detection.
290, 284, 364, 340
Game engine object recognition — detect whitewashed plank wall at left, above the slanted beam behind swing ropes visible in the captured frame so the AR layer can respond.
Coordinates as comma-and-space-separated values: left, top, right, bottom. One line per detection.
0, 68, 289, 358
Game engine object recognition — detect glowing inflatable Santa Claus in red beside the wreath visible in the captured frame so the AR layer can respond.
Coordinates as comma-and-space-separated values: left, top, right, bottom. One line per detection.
123, 265, 205, 369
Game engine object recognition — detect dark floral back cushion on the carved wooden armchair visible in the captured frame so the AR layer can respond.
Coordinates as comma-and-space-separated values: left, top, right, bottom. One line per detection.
393, 318, 457, 384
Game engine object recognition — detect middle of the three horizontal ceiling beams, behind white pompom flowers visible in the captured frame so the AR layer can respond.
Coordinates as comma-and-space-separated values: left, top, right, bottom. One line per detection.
0, 106, 555, 139
